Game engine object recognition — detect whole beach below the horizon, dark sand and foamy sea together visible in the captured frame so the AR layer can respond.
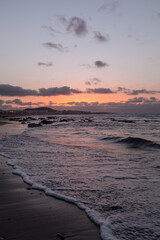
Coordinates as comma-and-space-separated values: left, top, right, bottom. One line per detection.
0, 114, 160, 240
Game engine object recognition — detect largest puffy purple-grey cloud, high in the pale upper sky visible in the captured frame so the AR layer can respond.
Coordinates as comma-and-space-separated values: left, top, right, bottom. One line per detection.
65, 17, 88, 37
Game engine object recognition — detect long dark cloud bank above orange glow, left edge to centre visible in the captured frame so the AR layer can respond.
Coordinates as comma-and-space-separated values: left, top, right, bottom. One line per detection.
0, 84, 82, 97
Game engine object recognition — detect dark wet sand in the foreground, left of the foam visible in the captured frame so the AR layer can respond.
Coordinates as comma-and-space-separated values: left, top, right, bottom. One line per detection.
0, 122, 101, 240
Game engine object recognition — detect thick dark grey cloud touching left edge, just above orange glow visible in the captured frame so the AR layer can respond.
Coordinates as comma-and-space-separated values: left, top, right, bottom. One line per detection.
0, 84, 38, 96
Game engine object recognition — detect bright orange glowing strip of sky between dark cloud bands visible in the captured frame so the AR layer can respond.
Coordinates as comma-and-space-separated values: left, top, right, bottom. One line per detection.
3, 92, 160, 108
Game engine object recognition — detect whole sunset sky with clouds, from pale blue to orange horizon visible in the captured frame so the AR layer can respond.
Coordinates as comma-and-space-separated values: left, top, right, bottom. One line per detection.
0, 0, 160, 113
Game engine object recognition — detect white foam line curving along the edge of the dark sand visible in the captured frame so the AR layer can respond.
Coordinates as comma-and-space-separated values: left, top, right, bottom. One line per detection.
7, 159, 118, 240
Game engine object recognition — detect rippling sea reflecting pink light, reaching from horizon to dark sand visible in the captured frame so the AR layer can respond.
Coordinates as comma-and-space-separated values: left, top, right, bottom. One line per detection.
0, 114, 160, 240
